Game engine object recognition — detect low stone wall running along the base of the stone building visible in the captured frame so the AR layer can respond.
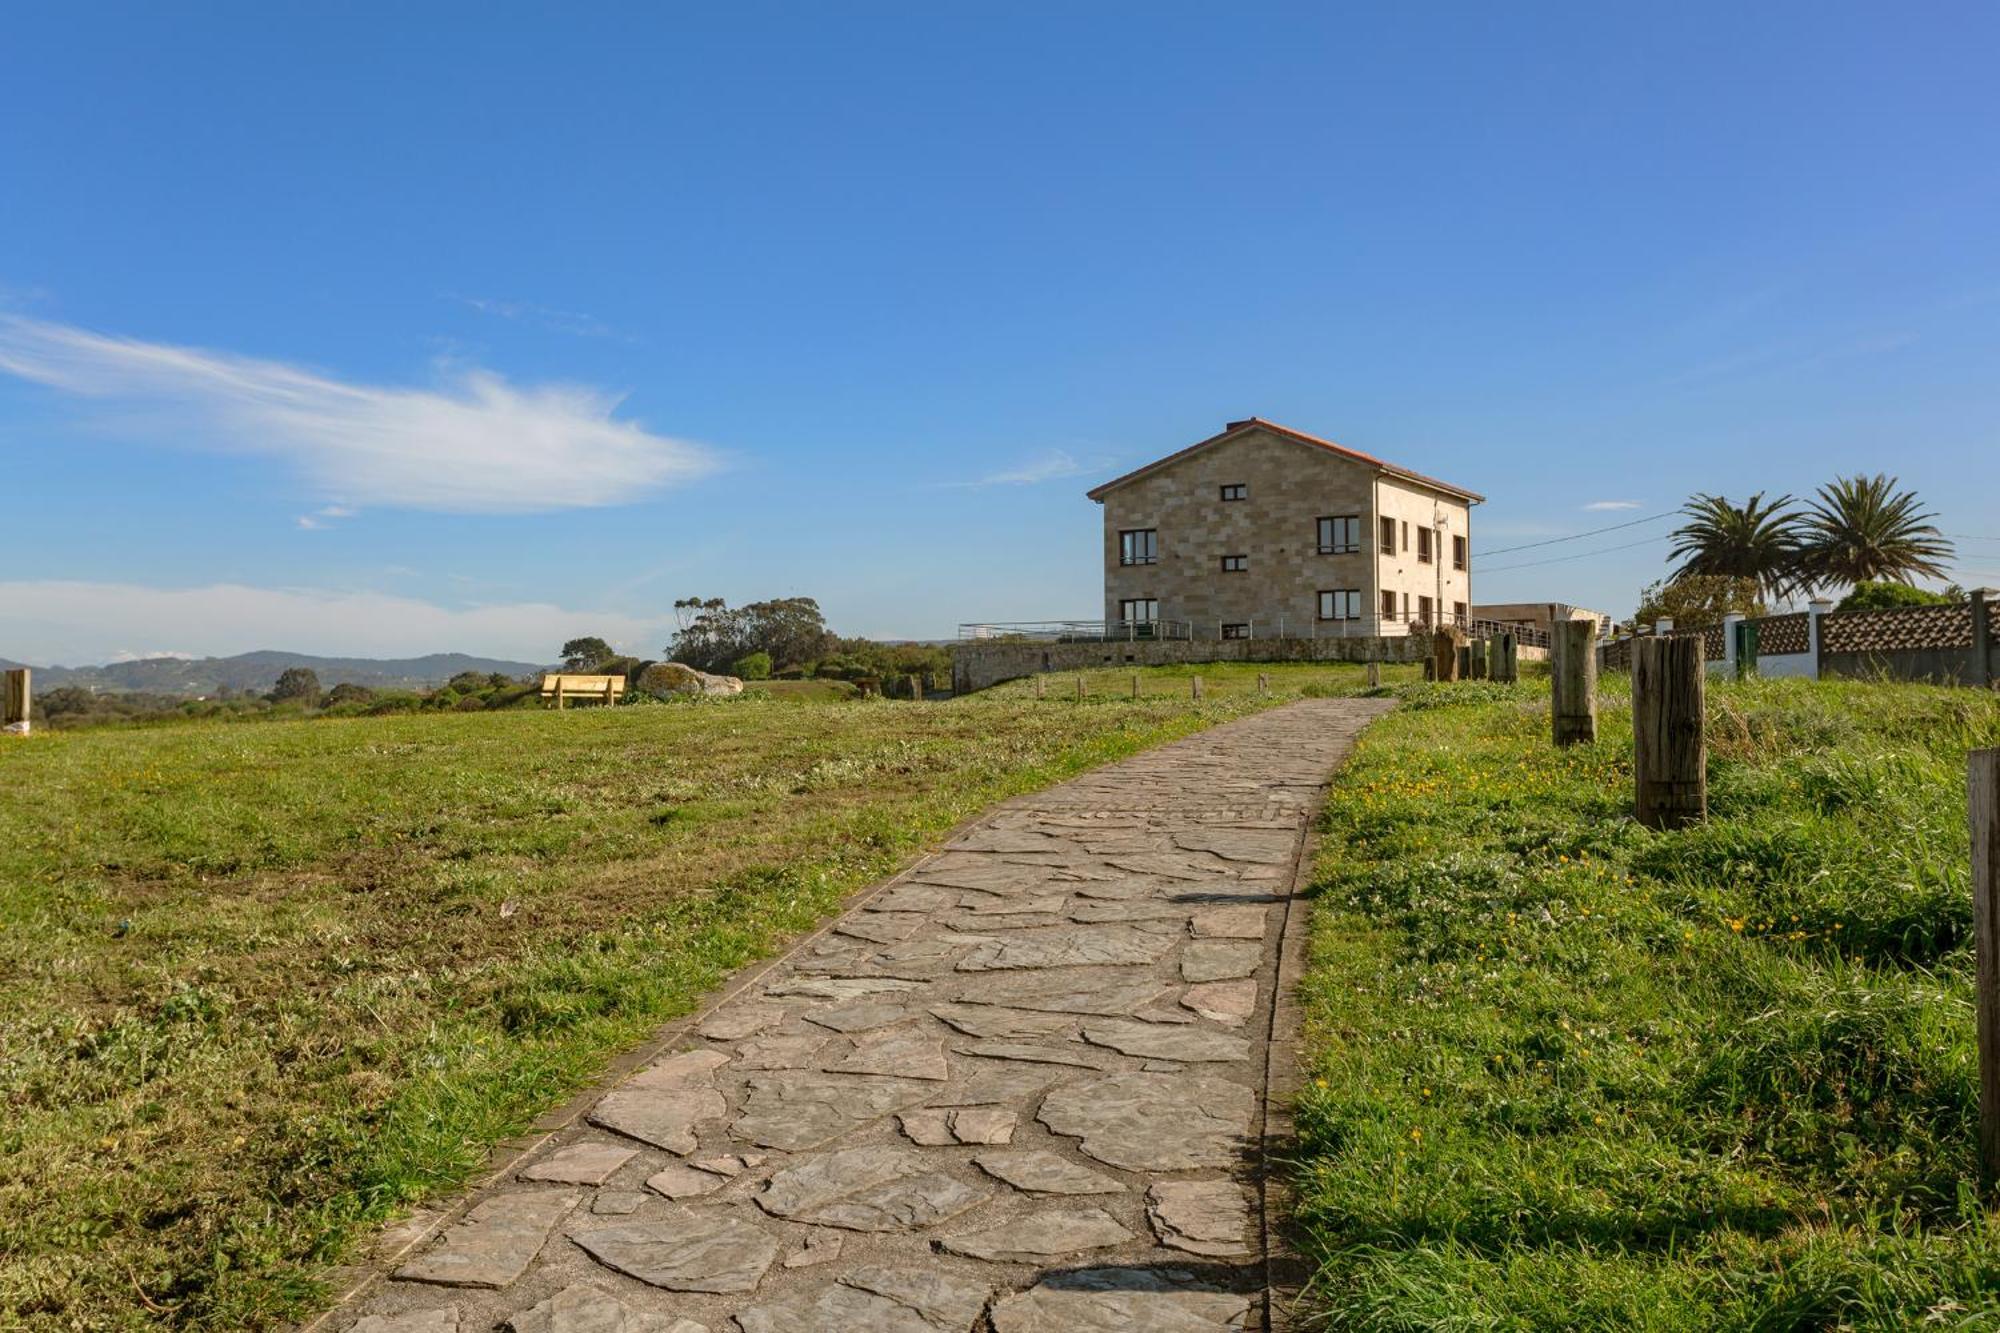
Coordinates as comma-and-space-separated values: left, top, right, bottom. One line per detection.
952, 634, 1430, 695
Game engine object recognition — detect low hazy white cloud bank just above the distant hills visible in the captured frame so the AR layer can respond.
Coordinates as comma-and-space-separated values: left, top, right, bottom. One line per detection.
0, 580, 674, 664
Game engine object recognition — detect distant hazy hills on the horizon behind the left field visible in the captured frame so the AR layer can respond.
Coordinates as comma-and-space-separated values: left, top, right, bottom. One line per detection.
0, 650, 542, 695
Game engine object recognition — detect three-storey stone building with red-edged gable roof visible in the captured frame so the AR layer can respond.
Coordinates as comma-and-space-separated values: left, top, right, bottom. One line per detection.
1090, 416, 1484, 638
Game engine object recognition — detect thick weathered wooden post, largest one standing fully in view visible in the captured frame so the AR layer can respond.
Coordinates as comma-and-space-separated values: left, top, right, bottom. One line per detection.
1632, 634, 1708, 829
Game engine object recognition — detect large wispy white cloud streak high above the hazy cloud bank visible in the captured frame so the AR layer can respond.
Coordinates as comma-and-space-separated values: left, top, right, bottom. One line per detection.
0, 316, 718, 514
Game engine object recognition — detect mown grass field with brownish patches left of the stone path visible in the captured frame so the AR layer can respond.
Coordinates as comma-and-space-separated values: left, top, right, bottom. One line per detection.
0, 667, 1362, 1333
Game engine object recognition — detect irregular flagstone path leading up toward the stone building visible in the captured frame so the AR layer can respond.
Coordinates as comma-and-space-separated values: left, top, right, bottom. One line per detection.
332, 701, 1386, 1333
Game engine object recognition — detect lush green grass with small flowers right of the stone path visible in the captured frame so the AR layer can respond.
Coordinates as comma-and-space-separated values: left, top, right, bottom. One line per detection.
1296, 677, 2000, 1329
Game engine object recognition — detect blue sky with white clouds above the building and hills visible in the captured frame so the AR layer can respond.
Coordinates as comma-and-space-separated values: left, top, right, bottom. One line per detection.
0, 2, 2000, 662
